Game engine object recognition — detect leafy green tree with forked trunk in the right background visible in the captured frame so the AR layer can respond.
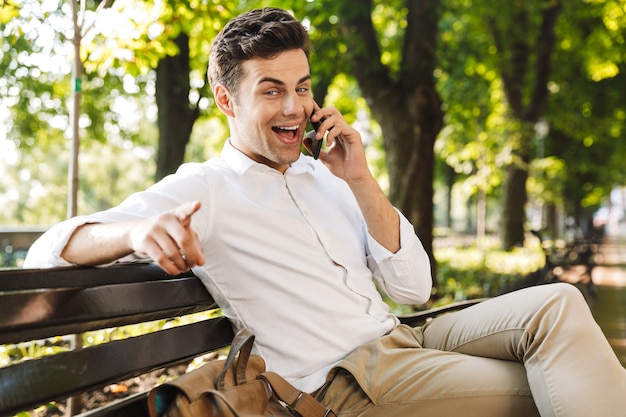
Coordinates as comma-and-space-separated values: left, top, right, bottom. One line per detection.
438, 0, 626, 247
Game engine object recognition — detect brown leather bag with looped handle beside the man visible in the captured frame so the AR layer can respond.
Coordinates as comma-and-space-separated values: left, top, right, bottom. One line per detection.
148, 329, 336, 417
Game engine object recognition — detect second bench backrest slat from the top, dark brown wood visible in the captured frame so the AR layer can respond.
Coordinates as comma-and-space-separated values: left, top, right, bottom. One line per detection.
0, 277, 217, 344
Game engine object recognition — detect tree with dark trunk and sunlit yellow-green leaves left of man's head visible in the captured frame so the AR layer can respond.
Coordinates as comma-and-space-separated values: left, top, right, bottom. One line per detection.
83, 0, 236, 180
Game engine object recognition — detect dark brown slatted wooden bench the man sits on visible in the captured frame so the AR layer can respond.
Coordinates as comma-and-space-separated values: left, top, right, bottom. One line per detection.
0, 264, 479, 417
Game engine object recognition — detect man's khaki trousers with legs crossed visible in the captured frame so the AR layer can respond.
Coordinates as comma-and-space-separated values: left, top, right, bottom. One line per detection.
315, 284, 626, 417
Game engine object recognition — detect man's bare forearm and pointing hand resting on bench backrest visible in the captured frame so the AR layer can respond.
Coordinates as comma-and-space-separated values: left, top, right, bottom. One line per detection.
61, 201, 204, 275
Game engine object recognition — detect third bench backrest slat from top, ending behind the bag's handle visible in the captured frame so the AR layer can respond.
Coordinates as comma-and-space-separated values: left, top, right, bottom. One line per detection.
0, 317, 233, 415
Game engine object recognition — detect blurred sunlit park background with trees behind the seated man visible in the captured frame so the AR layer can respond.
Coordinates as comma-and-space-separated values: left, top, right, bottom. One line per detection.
0, 0, 626, 356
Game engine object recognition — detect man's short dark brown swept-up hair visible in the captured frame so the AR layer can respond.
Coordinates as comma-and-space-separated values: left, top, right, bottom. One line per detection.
208, 7, 311, 95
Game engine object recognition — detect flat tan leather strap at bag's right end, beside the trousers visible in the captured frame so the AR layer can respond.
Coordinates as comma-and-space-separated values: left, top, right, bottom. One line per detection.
257, 371, 337, 417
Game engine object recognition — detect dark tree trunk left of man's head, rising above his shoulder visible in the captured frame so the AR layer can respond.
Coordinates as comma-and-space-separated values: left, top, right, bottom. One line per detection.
155, 33, 198, 181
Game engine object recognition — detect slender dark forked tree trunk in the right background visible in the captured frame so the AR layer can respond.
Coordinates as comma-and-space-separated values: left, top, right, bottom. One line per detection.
487, 1, 561, 250
